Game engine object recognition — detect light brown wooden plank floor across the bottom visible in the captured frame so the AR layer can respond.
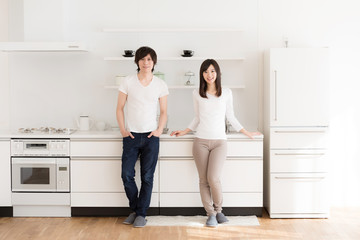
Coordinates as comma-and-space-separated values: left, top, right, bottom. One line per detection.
0, 208, 360, 240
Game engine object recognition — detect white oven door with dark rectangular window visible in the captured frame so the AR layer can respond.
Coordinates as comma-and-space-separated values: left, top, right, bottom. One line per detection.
11, 157, 56, 192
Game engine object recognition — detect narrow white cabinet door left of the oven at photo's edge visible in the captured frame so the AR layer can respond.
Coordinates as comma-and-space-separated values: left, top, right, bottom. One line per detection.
0, 140, 11, 206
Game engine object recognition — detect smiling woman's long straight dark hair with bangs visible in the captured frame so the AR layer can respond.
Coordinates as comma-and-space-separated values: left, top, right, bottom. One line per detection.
199, 59, 222, 98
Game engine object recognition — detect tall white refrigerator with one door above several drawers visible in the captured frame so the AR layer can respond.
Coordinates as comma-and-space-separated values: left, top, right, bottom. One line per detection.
264, 48, 329, 218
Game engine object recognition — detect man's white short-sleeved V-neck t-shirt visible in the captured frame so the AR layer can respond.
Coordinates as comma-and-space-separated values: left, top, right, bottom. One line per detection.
119, 74, 169, 133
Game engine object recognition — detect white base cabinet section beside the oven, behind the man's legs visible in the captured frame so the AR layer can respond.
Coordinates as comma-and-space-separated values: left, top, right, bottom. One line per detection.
71, 139, 159, 207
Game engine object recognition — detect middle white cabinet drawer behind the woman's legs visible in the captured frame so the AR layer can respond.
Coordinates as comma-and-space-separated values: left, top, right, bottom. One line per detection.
160, 159, 263, 193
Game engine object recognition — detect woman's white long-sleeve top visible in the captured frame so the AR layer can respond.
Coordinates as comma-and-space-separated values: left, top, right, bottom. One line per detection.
188, 88, 243, 139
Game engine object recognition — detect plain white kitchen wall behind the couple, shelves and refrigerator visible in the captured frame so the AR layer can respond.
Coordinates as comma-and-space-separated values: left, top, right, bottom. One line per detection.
0, 0, 360, 206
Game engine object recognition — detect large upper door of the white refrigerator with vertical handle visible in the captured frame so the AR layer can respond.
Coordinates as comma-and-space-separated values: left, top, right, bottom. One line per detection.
268, 48, 329, 126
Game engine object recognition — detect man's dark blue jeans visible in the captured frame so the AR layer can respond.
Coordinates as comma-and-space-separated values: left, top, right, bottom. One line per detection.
121, 132, 159, 217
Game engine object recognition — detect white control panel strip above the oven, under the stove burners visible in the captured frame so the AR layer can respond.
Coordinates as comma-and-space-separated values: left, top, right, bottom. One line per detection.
11, 139, 70, 156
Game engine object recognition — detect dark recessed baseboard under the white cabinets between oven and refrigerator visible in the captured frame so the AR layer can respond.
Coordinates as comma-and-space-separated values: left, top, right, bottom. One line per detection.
71, 207, 262, 217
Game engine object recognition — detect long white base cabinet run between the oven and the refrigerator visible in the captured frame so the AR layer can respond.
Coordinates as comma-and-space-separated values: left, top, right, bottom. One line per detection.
70, 134, 263, 215
